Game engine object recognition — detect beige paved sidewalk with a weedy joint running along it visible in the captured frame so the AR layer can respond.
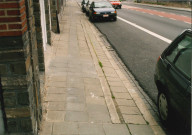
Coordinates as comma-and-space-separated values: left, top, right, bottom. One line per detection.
40, 0, 165, 135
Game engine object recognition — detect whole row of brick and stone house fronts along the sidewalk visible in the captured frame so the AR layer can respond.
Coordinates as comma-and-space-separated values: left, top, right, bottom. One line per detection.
0, 0, 64, 135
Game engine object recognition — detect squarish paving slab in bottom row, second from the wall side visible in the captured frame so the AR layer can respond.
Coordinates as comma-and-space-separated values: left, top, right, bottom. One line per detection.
53, 122, 79, 135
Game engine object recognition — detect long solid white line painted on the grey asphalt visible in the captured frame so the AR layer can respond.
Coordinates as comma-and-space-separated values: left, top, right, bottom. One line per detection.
117, 16, 172, 44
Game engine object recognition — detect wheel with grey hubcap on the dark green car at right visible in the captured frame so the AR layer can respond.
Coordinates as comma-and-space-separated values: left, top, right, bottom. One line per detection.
158, 92, 170, 126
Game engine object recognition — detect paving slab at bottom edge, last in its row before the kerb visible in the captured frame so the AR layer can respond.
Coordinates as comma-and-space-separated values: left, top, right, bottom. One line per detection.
128, 124, 154, 135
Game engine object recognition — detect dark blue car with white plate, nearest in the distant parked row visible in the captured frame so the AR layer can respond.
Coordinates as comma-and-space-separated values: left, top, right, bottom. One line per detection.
89, 1, 117, 21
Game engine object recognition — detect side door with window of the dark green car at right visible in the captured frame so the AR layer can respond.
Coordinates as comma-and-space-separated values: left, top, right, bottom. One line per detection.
164, 33, 192, 124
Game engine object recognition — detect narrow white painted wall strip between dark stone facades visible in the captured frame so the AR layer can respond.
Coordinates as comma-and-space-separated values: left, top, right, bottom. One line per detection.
40, 0, 47, 51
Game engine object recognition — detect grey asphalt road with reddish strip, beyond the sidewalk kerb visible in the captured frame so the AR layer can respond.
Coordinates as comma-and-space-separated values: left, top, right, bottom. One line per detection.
94, 2, 191, 102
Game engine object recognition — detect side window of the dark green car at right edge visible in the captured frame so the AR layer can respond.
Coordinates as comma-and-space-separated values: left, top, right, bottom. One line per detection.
166, 35, 192, 78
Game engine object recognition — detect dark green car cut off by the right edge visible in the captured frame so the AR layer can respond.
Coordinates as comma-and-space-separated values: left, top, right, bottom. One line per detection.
154, 29, 192, 132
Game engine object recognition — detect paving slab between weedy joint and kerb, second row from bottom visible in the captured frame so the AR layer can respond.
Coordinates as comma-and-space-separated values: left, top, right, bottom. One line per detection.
123, 114, 146, 124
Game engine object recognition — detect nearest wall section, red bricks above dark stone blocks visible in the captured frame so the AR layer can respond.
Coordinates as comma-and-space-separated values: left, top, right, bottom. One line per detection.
0, 0, 41, 134
